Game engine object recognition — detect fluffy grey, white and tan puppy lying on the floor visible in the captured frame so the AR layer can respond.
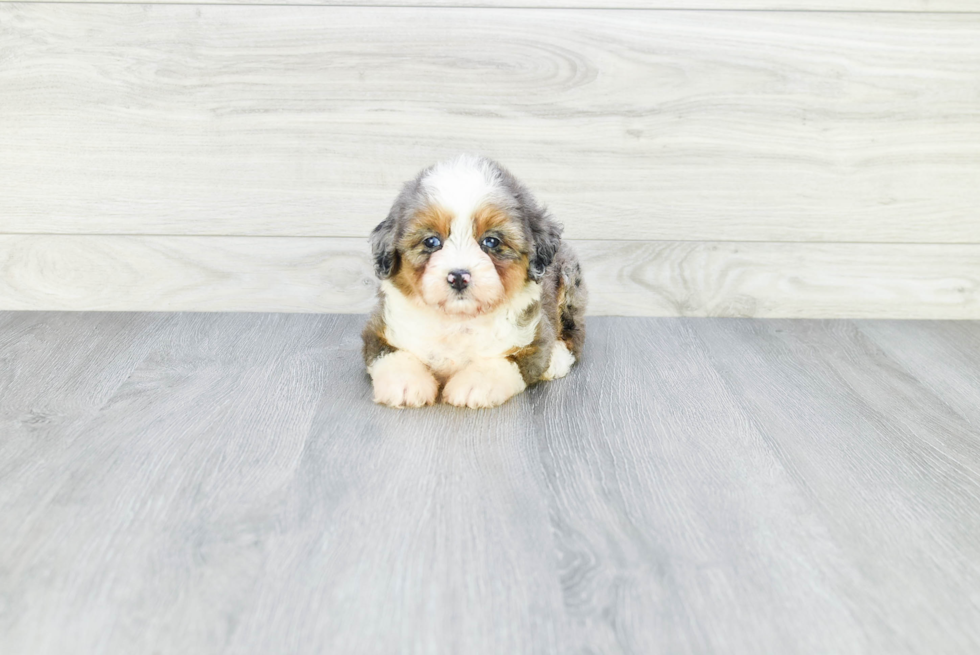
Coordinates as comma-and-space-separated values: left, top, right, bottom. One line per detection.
363, 156, 586, 408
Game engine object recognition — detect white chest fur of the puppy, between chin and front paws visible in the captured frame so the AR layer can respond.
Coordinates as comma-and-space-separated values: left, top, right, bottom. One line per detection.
382, 281, 541, 375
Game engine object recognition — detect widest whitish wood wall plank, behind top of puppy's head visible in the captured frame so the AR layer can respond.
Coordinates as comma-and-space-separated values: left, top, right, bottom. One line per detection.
0, 4, 980, 243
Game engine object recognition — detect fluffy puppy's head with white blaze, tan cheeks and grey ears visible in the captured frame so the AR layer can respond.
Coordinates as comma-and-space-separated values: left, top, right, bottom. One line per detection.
371, 156, 561, 316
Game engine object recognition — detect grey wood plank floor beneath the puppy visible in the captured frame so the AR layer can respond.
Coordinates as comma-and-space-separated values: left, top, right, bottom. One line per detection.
0, 312, 980, 655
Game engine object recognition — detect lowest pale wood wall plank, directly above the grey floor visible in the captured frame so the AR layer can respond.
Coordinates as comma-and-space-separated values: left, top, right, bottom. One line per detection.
0, 235, 980, 319
